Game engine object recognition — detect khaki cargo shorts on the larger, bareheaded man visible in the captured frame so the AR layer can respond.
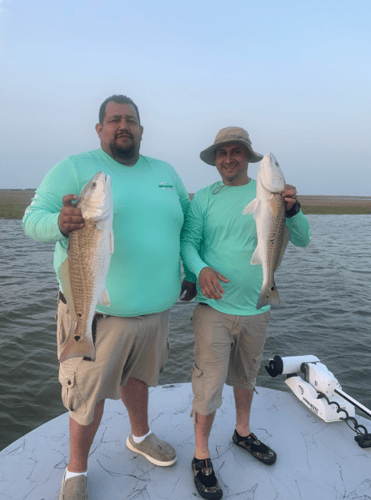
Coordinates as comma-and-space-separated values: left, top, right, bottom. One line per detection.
57, 299, 169, 425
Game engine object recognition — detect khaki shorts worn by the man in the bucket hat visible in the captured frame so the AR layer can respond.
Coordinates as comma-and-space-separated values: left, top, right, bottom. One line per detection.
192, 304, 270, 415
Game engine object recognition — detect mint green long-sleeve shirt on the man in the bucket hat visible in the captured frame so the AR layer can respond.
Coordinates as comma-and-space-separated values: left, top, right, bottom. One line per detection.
181, 179, 311, 316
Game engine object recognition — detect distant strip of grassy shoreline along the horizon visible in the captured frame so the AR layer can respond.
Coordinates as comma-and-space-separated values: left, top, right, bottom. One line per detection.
0, 189, 371, 219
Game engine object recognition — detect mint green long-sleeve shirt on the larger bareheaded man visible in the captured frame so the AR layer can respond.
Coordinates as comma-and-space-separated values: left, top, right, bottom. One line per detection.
23, 149, 194, 316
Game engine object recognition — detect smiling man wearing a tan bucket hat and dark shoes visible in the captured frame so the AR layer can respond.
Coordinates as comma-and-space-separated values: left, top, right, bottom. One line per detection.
181, 127, 310, 500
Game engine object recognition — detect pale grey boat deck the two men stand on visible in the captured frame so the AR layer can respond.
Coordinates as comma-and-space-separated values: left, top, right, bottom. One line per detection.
0, 384, 371, 500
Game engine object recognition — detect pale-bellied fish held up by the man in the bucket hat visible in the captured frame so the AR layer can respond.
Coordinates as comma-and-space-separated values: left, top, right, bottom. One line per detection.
243, 153, 290, 309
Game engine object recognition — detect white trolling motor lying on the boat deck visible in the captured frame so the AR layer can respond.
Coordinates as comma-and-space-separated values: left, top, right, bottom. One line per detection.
265, 355, 371, 448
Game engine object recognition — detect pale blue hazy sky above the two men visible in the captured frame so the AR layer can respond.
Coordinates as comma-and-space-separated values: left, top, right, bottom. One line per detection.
0, 0, 371, 196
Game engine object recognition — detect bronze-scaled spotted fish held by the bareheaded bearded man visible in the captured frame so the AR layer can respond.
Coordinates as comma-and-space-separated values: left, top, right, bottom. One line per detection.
59, 172, 113, 363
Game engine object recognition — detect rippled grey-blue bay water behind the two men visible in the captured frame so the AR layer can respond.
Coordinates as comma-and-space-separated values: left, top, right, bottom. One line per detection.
0, 215, 371, 450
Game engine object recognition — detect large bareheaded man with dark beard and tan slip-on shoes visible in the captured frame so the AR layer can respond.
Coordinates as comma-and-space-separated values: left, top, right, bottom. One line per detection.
23, 95, 195, 500
